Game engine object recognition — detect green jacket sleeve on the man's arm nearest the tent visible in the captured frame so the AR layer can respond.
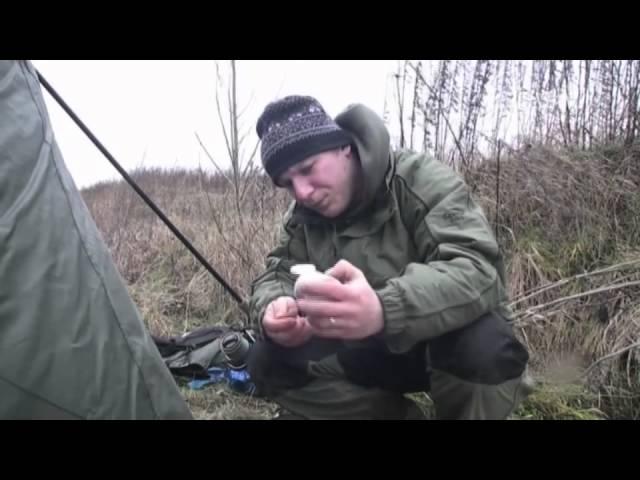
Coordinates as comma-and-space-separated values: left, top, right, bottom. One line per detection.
249, 205, 309, 333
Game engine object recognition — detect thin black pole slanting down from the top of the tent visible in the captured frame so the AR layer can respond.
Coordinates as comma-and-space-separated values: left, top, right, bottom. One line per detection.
36, 70, 248, 313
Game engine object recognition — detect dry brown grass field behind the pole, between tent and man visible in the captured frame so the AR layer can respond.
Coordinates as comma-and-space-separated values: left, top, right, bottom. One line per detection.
83, 170, 287, 335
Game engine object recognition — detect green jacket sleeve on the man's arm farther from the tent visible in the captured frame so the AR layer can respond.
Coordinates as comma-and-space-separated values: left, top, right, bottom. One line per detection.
377, 153, 503, 353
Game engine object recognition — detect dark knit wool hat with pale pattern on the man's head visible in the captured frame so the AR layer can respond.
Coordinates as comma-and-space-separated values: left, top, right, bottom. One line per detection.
256, 95, 351, 181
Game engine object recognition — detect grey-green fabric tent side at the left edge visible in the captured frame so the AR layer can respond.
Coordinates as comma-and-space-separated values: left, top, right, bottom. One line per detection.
0, 60, 192, 419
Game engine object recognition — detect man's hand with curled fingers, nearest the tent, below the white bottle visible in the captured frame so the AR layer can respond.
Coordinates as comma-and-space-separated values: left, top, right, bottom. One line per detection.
262, 297, 312, 347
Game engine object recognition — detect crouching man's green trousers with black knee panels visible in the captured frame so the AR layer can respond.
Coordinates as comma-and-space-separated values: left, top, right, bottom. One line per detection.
249, 313, 528, 419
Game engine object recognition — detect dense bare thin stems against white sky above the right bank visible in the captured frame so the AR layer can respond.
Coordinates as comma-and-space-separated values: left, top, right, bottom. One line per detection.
382, 60, 640, 167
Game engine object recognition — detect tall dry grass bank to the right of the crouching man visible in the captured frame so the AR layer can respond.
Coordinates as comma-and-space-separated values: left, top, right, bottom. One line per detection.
467, 141, 640, 418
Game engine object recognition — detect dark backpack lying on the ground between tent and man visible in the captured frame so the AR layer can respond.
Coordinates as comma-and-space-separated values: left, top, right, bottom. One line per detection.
152, 325, 255, 379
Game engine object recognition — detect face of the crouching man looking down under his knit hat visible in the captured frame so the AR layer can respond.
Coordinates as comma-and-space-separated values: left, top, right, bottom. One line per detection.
277, 146, 356, 218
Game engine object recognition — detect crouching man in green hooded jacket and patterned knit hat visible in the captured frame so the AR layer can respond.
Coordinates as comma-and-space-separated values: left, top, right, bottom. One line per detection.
245, 96, 528, 419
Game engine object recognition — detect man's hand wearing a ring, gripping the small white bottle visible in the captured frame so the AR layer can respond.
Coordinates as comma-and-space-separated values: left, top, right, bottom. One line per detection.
297, 260, 384, 340
